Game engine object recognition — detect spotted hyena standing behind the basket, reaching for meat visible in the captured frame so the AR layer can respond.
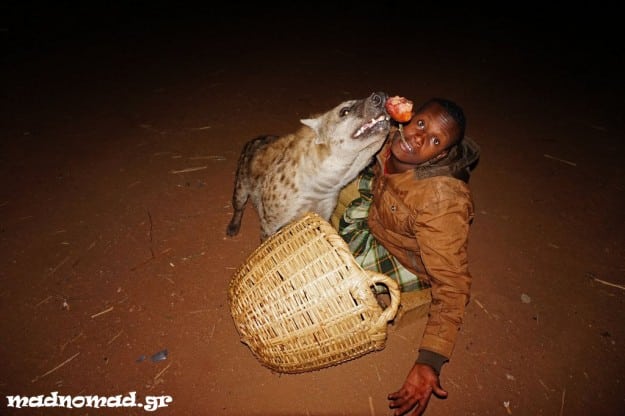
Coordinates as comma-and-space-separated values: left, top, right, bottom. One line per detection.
227, 92, 390, 240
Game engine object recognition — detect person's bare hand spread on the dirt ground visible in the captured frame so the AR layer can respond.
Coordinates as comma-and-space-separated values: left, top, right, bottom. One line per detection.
388, 363, 447, 416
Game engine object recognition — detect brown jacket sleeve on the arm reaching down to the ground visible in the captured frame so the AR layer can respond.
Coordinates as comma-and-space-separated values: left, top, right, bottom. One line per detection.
412, 184, 473, 359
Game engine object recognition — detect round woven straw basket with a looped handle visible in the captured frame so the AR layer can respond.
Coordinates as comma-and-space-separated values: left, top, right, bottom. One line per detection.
228, 213, 400, 373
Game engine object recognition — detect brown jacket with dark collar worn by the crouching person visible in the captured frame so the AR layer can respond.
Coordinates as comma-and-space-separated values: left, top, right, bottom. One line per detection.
369, 138, 479, 359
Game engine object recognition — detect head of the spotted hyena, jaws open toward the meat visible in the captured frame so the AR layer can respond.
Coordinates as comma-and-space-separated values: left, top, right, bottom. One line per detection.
300, 92, 390, 152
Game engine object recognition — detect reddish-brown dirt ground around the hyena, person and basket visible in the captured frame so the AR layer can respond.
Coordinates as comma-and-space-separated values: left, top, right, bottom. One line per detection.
0, 2, 625, 416
